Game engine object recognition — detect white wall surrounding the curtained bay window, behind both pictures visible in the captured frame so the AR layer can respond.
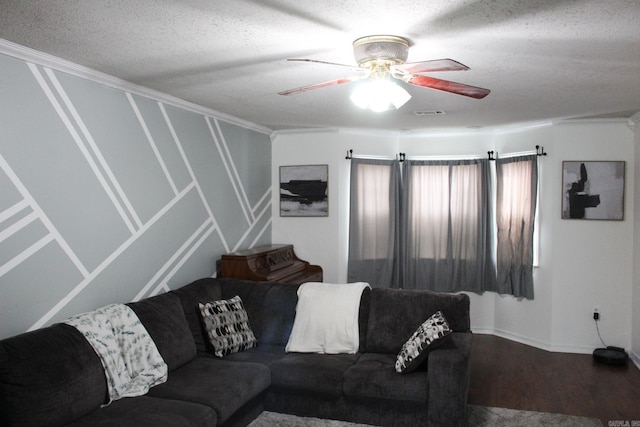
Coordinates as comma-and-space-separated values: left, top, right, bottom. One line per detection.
272, 121, 640, 353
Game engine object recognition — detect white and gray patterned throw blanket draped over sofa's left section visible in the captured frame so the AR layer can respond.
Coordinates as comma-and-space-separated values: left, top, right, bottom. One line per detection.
65, 304, 168, 404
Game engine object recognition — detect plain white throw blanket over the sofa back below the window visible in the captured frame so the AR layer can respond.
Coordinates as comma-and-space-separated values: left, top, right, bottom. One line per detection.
286, 282, 371, 354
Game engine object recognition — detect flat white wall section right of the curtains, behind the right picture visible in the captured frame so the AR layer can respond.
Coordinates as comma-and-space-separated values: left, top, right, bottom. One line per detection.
549, 122, 635, 352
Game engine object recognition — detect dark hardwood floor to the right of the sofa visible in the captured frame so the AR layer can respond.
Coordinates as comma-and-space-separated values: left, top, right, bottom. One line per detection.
469, 334, 640, 427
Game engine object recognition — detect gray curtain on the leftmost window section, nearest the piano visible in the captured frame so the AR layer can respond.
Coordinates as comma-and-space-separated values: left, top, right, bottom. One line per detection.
347, 158, 400, 287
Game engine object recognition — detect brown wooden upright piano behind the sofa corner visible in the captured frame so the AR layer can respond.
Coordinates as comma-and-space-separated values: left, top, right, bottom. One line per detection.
219, 245, 322, 284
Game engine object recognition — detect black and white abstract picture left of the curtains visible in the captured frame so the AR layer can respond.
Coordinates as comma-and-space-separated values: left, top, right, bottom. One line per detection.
280, 165, 329, 217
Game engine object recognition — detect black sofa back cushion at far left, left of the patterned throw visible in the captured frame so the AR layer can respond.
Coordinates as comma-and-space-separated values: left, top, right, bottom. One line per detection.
0, 323, 107, 426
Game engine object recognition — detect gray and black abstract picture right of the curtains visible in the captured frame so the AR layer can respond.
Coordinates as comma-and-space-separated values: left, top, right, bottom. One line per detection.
562, 160, 626, 221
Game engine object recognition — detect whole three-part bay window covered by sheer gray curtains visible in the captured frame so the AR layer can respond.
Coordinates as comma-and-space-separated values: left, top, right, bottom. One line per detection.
348, 155, 537, 298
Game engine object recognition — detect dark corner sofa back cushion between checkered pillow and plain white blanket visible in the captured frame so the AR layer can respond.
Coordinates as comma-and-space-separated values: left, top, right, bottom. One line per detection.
218, 279, 299, 346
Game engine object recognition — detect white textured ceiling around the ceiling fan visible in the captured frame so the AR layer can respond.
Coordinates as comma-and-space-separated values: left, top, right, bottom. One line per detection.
0, 0, 640, 130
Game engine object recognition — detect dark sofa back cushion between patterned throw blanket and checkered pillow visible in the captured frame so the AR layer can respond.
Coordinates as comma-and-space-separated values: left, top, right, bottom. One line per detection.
127, 293, 196, 371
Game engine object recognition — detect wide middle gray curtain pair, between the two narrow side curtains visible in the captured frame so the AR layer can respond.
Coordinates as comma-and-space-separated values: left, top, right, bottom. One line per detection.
400, 159, 495, 292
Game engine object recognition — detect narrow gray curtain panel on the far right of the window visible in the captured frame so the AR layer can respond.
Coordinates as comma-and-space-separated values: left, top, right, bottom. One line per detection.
496, 154, 538, 299
